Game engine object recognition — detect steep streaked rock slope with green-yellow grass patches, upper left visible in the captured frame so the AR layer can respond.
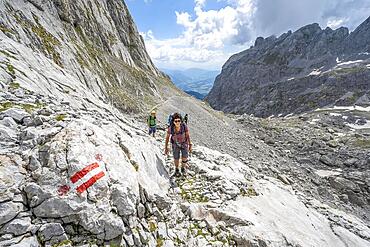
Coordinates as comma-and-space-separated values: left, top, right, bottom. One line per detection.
0, 0, 179, 112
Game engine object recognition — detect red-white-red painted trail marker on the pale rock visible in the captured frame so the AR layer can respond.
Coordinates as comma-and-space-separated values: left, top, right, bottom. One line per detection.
58, 162, 105, 196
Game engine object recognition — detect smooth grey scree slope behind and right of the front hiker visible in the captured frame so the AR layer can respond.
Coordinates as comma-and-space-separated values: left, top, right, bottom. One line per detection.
157, 96, 276, 164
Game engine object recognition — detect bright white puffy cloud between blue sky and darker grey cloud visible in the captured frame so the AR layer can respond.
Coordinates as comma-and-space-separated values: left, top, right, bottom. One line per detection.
142, 0, 253, 69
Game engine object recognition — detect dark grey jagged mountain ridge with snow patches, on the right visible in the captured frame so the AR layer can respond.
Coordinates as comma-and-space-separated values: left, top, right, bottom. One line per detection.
206, 18, 370, 117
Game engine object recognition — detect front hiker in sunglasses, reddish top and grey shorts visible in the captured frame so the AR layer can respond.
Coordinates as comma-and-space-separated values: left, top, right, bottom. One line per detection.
164, 113, 192, 177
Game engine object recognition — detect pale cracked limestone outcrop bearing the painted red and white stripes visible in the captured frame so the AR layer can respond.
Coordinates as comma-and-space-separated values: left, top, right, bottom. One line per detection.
0, 86, 173, 246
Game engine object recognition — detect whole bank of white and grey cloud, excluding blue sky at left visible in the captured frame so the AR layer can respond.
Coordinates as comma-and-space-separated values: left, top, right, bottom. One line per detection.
143, 0, 370, 69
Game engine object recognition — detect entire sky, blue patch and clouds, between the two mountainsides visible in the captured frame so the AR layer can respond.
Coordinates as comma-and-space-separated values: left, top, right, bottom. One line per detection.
125, 0, 370, 70
